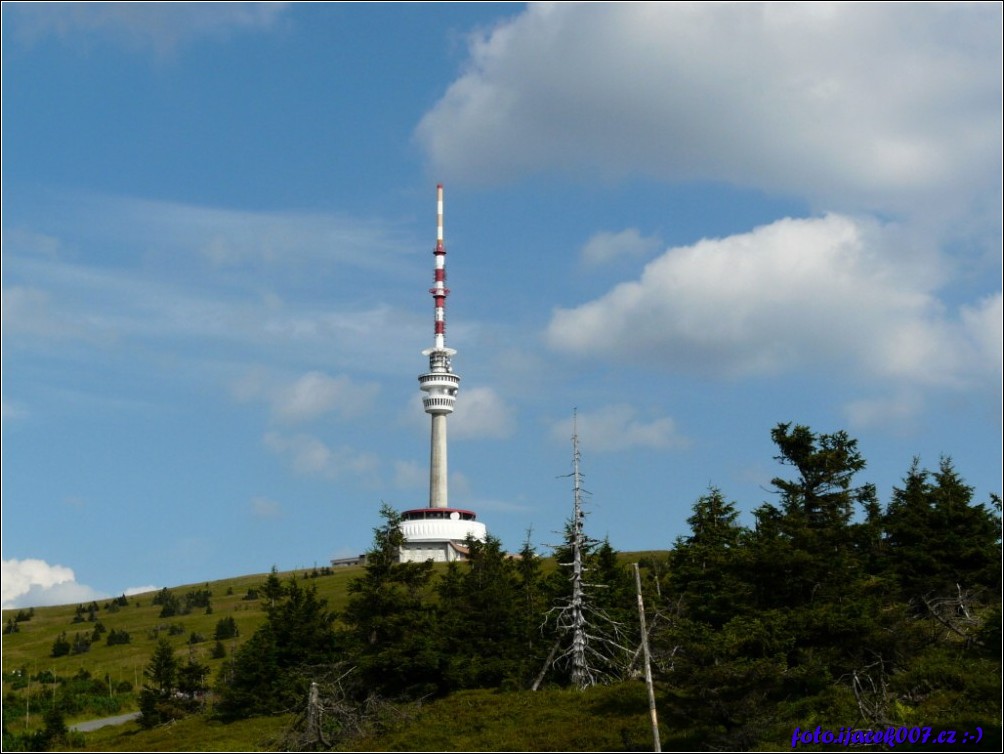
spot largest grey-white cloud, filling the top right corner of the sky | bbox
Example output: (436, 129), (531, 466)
(417, 3), (1001, 219)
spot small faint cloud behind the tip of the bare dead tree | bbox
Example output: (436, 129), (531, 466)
(551, 404), (689, 453)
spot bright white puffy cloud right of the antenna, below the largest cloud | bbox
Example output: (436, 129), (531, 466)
(546, 215), (1000, 386)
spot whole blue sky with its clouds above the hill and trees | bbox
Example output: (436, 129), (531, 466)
(2, 3), (1002, 606)
